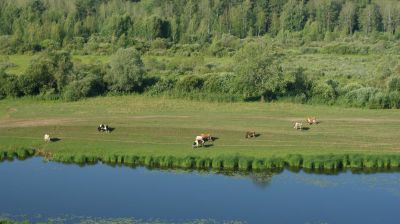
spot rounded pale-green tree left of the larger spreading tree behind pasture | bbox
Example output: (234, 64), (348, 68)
(104, 48), (146, 92)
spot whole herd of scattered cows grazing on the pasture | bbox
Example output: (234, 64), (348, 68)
(44, 117), (319, 148)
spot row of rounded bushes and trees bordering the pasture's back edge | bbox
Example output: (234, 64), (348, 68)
(0, 42), (400, 109)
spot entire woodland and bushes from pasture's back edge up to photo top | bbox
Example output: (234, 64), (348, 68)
(0, 0), (400, 108)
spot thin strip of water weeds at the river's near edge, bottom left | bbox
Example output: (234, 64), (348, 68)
(0, 214), (245, 224)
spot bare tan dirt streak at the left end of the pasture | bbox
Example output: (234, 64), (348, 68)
(0, 118), (82, 127)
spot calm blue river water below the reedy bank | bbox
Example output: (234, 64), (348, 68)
(0, 158), (400, 223)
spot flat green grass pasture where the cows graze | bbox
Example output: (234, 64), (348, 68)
(0, 96), (400, 171)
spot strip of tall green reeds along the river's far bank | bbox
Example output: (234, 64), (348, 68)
(0, 149), (400, 171)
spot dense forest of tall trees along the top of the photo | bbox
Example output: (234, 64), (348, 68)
(0, 0), (400, 53)
